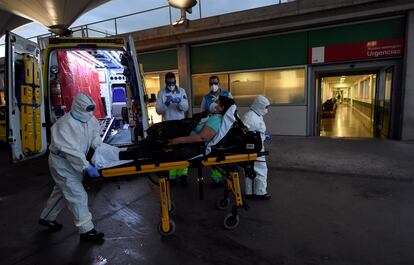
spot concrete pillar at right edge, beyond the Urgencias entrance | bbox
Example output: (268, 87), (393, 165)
(401, 10), (414, 140)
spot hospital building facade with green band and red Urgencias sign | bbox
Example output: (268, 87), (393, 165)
(127, 0), (414, 140)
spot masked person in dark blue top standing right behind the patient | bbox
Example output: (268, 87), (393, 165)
(200, 75), (233, 188)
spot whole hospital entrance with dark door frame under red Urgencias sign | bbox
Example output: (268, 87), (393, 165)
(311, 60), (401, 139)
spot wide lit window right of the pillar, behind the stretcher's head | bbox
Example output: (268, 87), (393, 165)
(193, 68), (305, 106)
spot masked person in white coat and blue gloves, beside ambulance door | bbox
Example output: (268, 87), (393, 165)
(156, 72), (188, 186)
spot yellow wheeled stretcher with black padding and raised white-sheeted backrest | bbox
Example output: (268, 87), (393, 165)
(97, 106), (267, 236)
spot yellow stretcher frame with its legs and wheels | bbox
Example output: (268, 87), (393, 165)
(101, 153), (258, 236)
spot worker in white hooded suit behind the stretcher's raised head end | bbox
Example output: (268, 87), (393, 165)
(242, 95), (271, 200)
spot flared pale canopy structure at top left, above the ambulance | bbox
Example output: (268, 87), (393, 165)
(0, 0), (109, 35)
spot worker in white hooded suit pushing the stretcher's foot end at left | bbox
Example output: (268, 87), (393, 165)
(39, 93), (104, 241)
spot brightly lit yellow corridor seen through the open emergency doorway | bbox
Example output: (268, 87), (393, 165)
(320, 73), (377, 138)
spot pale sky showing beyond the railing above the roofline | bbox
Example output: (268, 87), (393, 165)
(0, 0), (296, 47)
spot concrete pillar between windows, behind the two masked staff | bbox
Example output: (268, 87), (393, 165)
(177, 44), (193, 117)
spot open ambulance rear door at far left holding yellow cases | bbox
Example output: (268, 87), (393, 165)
(5, 32), (47, 162)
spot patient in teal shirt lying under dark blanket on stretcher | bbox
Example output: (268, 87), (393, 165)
(94, 96), (262, 168)
